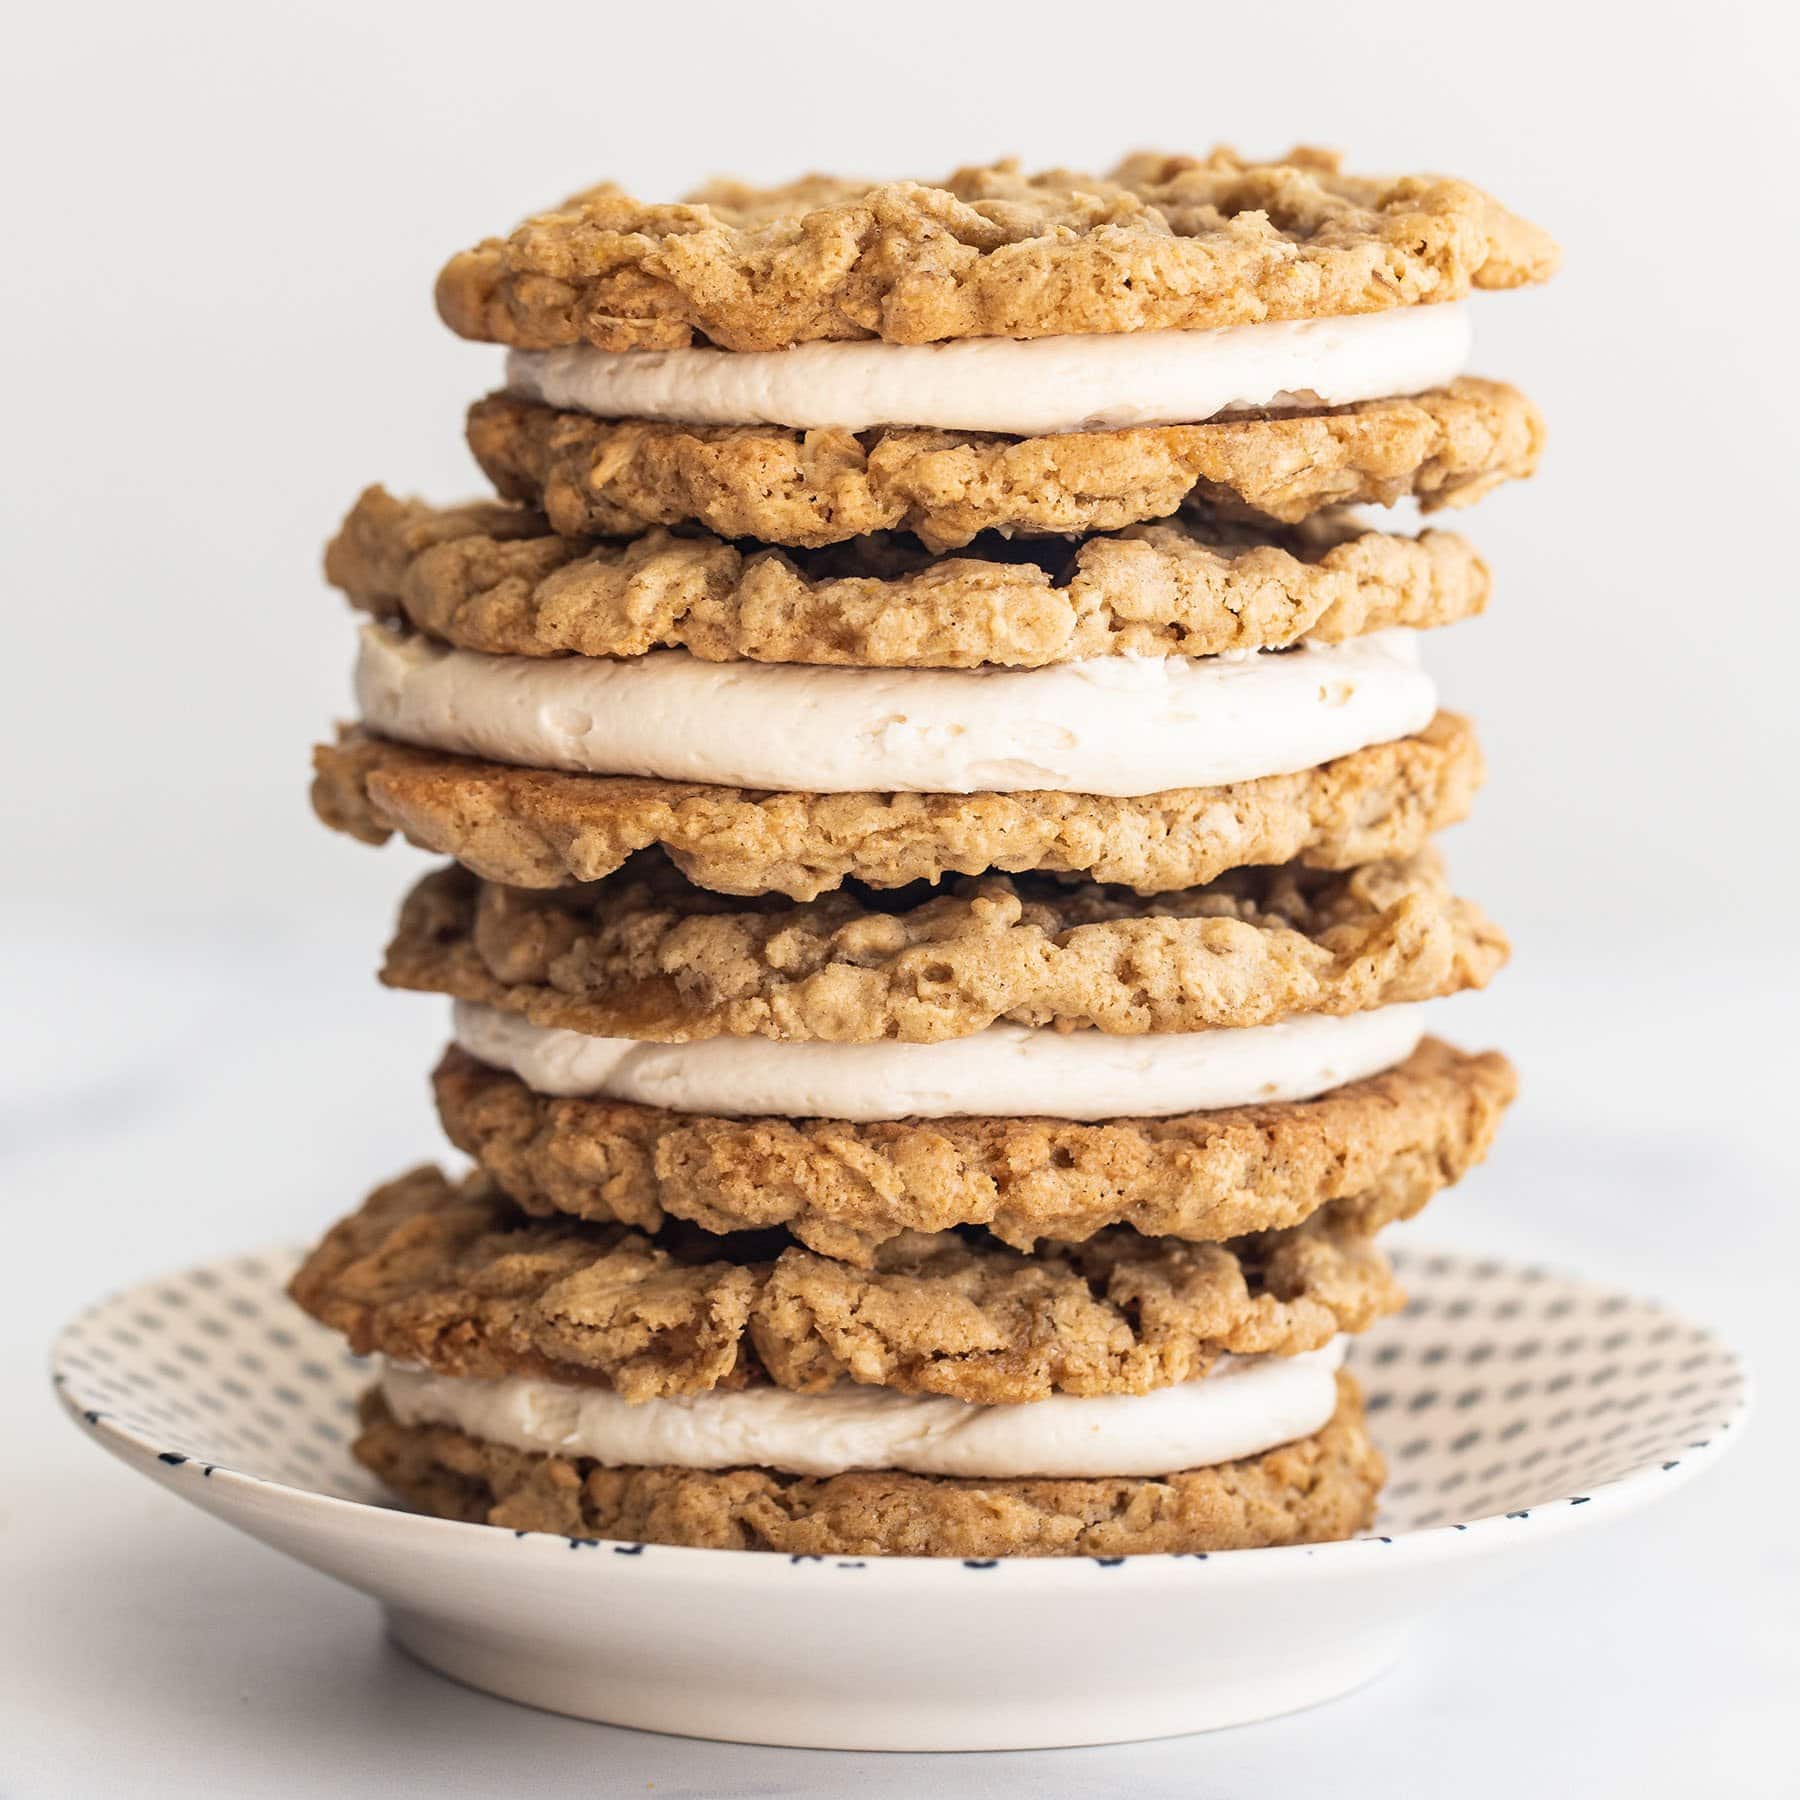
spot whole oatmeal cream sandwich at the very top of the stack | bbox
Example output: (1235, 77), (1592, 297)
(439, 151), (1555, 551)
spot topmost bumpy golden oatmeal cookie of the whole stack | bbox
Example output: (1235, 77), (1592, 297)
(437, 148), (1557, 351)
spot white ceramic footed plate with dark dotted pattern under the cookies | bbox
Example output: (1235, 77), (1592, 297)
(52, 1253), (1746, 1750)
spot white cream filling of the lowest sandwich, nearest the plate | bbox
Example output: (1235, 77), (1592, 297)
(382, 1337), (1345, 1480)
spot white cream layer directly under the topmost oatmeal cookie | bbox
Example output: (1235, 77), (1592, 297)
(506, 306), (1471, 437)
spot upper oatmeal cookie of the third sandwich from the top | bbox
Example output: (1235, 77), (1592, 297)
(382, 848), (1507, 1044)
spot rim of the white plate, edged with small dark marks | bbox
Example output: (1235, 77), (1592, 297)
(49, 1240), (1755, 1586)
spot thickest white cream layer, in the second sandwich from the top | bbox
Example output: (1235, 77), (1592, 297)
(356, 625), (1436, 796)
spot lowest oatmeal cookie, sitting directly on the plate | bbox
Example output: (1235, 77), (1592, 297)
(355, 1373), (1384, 1557)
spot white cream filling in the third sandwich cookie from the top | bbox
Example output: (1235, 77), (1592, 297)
(455, 1001), (1426, 1121)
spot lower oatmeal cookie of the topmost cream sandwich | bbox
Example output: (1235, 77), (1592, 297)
(468, 376), (1544, 551)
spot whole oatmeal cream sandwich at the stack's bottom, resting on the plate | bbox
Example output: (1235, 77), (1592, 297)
(293, 1170), (1400, 1555)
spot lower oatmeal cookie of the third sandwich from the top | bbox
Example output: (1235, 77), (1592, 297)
(432, 1039), (1516, 1267)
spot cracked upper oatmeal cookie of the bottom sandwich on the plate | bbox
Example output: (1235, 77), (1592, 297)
(290, 1168), (1404, 1404)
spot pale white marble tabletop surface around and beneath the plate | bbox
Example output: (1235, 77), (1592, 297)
(0, 907), (1800, 1800)
